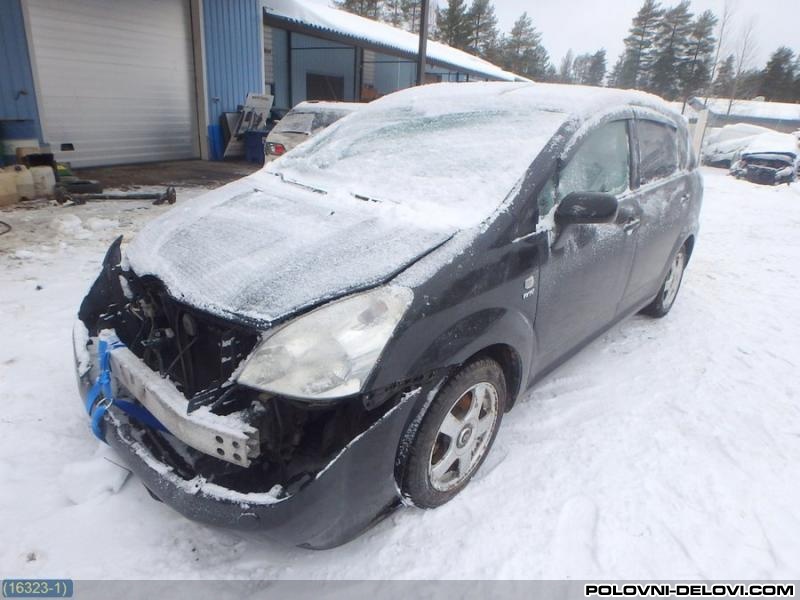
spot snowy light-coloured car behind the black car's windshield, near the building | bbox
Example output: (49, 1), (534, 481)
(264, 100), (365, 161)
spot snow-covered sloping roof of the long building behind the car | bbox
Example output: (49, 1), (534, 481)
(264, 0), (524, 81)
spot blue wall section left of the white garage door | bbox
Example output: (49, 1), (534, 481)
(0, 0), (40, 161)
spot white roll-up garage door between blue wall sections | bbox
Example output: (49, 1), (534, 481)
(25, 0), (199, 167)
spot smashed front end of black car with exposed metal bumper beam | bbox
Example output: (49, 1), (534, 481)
(74, 238), (430, 548)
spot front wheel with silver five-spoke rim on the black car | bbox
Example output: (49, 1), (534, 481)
(402, 358), (507, 508)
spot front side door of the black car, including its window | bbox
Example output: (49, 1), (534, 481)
(534, 119), (639, 371)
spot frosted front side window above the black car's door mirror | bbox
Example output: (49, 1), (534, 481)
(538, 121), (630, 216)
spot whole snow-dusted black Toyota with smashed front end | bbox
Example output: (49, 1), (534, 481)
(74, 83), (702, 548)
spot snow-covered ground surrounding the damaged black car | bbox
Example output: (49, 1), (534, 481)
(0, 169), (800, 579)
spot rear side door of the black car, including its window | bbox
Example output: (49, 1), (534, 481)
(623, 114), (691, 308)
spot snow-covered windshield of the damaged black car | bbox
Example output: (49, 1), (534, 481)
(267, 101), (566, 226)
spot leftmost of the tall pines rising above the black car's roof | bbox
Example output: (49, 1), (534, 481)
(615, 0), (664, 88)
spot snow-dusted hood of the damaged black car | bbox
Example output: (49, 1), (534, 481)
(126, 171), (455, 328)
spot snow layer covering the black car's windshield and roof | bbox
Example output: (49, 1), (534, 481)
(266, 82), (681, 229)
